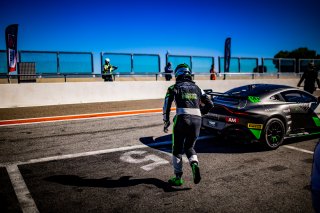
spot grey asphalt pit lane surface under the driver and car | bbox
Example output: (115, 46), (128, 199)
(0, 100), (318, 212)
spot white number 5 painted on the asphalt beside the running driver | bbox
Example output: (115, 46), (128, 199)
(120, 150), (169, 171)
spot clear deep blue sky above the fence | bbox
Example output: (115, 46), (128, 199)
(0, 0), (320, 58)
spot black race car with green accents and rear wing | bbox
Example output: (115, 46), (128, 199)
(202, 84), (320, 149)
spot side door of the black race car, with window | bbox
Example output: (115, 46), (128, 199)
(281, 90), (317, 133)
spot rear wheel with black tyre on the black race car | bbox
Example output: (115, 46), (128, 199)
(262, 118), (285, 149)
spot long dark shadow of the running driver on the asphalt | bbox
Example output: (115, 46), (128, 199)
(44, 175), (191, 192)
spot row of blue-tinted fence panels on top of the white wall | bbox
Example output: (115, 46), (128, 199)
(0, 50), (320, 82)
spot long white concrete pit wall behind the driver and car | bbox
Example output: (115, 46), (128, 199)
(0, 78), (318, 111)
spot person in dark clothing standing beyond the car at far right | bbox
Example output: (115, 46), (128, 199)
(297, 62), (320, 94)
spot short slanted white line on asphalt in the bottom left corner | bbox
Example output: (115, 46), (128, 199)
(6, 165), (39, 213)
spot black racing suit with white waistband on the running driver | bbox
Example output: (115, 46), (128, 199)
(163, 76), (213, 177)
